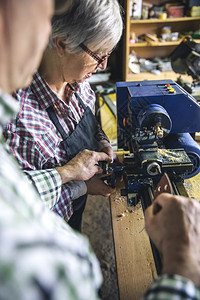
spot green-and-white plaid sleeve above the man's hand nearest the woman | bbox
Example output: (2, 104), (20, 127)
(24, 169), (62, 208)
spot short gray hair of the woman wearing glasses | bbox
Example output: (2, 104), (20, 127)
(49, 0), (123, 53)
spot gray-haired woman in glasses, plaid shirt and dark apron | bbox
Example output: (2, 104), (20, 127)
(5, 0), (122, 230)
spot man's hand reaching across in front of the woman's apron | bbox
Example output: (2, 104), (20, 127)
(56, 150), (111, 183)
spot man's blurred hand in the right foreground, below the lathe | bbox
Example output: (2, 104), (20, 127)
(145, 193), (200, 286)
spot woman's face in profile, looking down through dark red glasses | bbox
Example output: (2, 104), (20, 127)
(60, 51), (107, 83)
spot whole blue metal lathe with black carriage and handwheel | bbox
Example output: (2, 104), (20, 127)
(106, 80), (200, 274)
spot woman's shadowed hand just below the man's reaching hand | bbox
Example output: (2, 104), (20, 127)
(86, 175), (115, 197)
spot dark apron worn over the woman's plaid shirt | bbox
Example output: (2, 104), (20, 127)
(47, 93), (98, 231)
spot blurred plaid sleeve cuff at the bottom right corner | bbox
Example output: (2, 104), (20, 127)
(142, 275), (200, 300)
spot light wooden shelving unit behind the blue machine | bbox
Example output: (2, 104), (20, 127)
(123, 0), (200, 81)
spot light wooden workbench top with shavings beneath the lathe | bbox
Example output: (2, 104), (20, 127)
(110, 175), (200, 300)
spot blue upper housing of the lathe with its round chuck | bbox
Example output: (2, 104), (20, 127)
(116, 80), (200, 178)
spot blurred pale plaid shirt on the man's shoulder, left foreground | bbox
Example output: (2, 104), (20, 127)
(0, 91), (102, 300)
